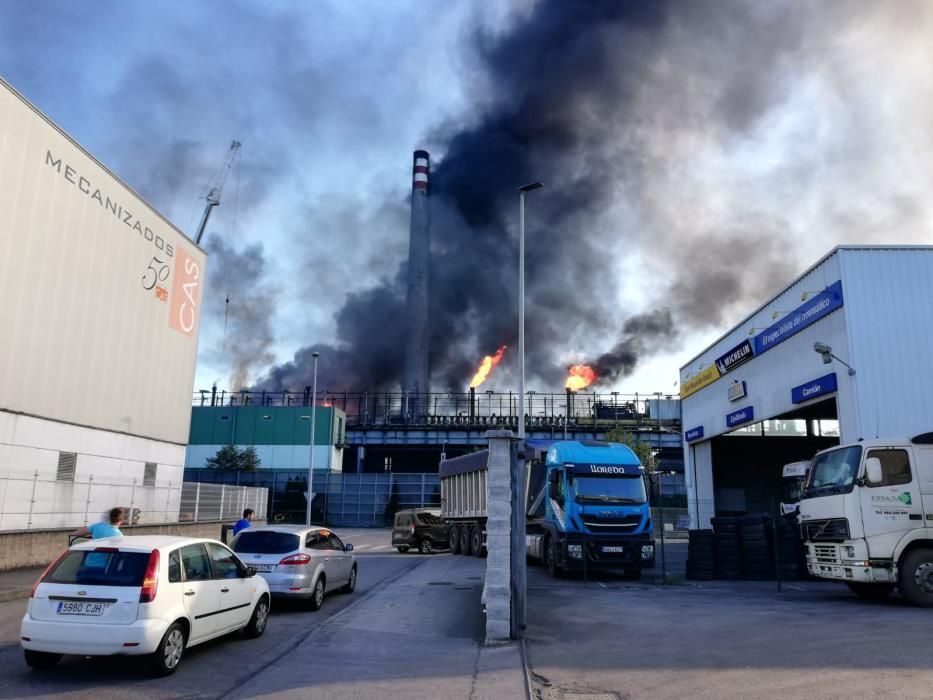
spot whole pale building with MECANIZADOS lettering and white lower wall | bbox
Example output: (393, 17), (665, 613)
(0, 80), (205, 530)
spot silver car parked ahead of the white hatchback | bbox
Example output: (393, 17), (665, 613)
(232, 525), (357, 610)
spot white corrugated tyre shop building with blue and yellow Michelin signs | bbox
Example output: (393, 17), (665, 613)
(680, 246), (933, 527)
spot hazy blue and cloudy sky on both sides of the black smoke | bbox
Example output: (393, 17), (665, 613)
(0, 0), (933, 392)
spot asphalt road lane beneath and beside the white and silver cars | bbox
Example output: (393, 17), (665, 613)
(0, 530), (425, 700)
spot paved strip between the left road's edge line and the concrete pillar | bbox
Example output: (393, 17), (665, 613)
(233, 556), (527, 700)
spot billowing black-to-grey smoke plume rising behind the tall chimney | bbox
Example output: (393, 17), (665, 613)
(256, 0), (932, 390)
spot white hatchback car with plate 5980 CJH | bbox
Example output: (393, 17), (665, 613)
(20, 536), (270, 675)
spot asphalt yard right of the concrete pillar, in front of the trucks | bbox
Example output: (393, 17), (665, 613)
(526, 567), (933, 699)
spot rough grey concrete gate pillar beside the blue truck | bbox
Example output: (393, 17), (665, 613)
(483, 430), (515, 644)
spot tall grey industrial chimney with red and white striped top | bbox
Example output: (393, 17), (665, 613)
(402, 151), (431, 416)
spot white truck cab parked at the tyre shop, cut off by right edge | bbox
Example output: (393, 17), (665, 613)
(800, 433), (933, 607)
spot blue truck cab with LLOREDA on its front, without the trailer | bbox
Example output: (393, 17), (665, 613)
(527, 440), (654, 579)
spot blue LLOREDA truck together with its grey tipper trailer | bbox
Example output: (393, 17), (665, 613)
(440, 440), (655, 579)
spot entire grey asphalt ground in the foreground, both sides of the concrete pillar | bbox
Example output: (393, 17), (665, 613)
(0, 530), (933, 700)
